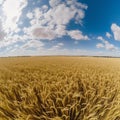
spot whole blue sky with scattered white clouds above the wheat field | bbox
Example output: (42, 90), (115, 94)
(0, 0), (120, 56)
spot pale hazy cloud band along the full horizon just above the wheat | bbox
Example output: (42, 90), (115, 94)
(3, 48), (120, 56)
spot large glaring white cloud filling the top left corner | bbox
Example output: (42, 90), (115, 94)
(0, 0), (27, 46)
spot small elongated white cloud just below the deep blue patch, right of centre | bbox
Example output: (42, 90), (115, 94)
(68, 30), (89, 40)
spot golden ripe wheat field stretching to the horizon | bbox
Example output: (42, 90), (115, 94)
(0, 56), (120, 120)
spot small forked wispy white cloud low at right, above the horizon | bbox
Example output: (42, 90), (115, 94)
(96, 36), (118, 51)
